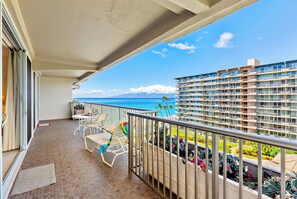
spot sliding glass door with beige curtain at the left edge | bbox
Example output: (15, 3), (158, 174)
(0, 5), (32, 198)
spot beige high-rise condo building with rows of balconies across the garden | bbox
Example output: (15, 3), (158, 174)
(176, 59), (297, 139)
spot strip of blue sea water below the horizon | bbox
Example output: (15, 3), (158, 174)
(74, 98), (175, 116)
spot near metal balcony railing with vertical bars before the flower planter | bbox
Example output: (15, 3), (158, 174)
(128, 113), (297, 199)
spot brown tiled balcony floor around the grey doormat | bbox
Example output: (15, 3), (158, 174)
(10, 120), (158, 199)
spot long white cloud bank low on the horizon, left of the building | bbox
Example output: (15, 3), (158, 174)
(129, 84), (176, 94)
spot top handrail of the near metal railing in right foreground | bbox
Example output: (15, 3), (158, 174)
(127, 112), (297, 150)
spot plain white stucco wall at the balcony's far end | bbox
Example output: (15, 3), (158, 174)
(40, 77), (75, 120)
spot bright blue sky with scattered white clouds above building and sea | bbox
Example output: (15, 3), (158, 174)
(74, 0), (297, 97)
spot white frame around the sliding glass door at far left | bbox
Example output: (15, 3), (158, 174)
(0, 3), (31, 198)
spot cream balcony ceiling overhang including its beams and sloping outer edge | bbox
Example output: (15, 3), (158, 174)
(4, 0), (256, 84)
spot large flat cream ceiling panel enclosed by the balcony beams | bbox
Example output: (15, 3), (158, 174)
(19, 0), (167, 65)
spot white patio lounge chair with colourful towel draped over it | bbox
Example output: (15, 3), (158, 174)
(84, 122), (128, 167)
